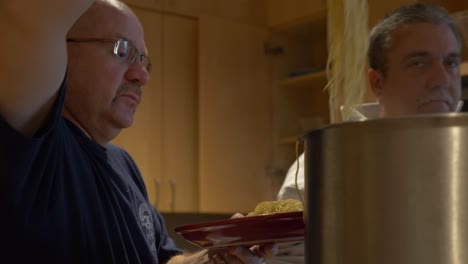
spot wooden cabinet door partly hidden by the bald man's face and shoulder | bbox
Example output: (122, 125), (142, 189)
(113, 8), (163, 205)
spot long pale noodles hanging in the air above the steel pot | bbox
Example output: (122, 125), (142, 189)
(325, 0), (369, 123)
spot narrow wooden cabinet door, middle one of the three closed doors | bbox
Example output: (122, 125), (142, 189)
(160, 15), (198, 212)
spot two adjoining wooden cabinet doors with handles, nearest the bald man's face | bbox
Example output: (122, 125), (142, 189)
(113, 6), (198, 212)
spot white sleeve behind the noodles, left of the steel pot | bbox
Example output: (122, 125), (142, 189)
(277, 153), (304, 200)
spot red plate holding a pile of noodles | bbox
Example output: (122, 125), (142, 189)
(175, 212), (304, 248)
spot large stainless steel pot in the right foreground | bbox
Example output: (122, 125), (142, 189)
(303, 114), (468, 264)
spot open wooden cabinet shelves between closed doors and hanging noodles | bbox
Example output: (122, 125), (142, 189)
(268, 0), (329, 173)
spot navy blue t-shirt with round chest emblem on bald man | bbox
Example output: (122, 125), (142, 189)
(0, 80), (181, 264)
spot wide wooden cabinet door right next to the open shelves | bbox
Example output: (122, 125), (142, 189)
(199, 17), (274, 213)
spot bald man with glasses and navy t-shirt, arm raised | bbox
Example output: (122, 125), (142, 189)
(0, 0), (276, 264)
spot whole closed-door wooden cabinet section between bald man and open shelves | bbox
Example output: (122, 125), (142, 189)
(114, 0), (276, 213)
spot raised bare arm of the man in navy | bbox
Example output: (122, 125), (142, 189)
(0, 0), (93, 135)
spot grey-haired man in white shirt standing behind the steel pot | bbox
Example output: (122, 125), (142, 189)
(267, 3), (463, 264)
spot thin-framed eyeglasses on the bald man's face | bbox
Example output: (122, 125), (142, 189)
(67, 38), (152, 72)
